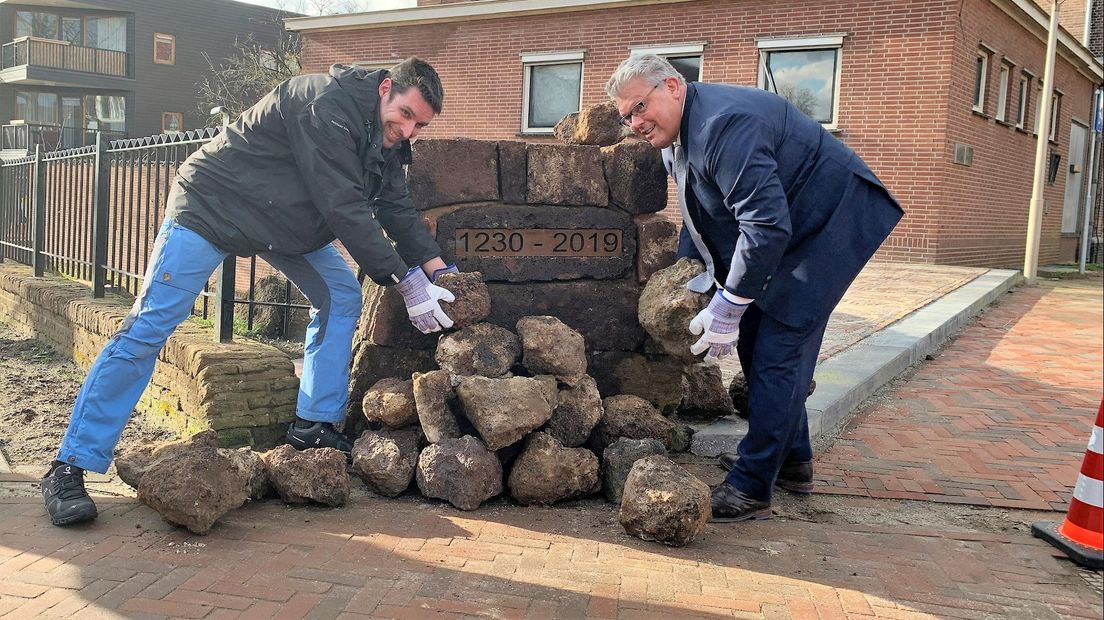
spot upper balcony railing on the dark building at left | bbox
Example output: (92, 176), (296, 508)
(0, 36), (129, 77)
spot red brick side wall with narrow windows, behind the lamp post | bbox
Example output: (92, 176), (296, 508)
(935, 0), (1092, 267)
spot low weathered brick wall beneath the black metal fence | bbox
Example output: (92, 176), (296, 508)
(0, 263), (299, 449)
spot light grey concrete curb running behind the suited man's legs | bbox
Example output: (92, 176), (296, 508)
(690, 269), (1023, 457)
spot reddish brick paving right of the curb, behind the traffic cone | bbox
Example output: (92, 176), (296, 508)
(816, 274), (1104, 512)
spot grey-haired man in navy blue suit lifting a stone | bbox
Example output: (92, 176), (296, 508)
(606, 54), (903, 522)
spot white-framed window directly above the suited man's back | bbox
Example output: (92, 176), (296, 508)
(758, 34), (843, 128)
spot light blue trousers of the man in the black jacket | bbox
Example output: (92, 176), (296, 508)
(57, 218), (361, 472)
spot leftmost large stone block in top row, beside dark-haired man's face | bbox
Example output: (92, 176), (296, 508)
(406, 138), (499, 210)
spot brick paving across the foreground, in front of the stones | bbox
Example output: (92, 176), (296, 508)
(0, 487), (1101, 619)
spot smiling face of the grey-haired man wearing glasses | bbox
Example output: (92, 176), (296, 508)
(614, 77), (687, 149)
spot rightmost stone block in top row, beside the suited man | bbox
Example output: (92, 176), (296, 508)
(602, 140), (667, 213)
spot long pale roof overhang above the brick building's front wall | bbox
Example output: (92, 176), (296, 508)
(284, 0), (691, 32)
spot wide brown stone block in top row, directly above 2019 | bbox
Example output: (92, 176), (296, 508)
(526, 145), (609, 206)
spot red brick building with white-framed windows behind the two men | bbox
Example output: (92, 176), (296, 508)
(287, 0), (1104, 267)
